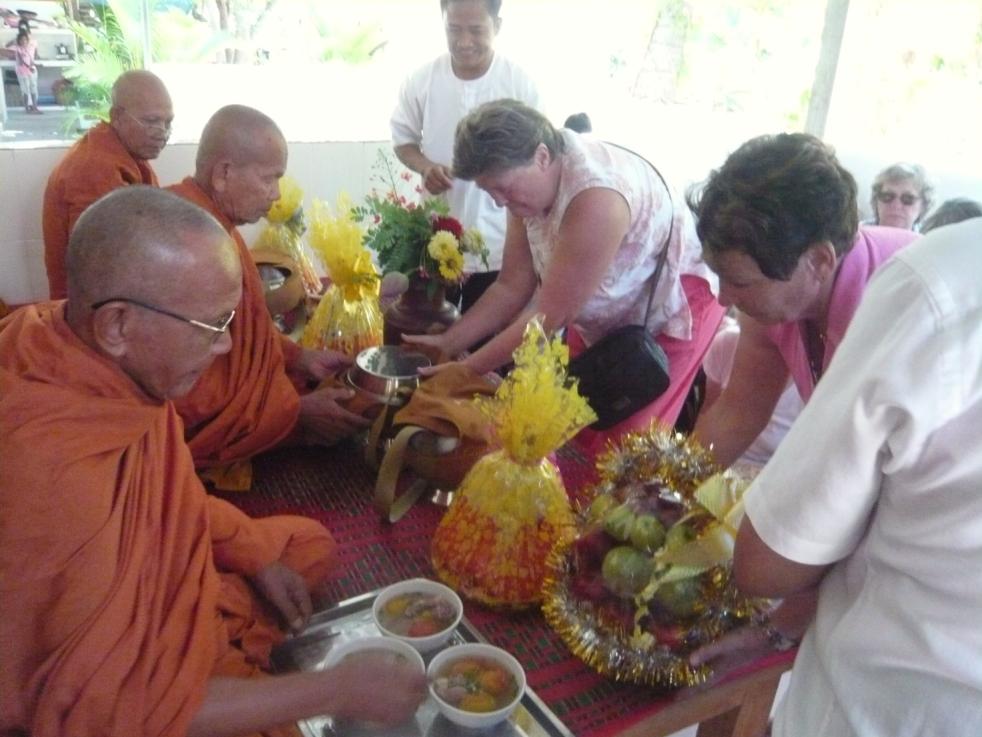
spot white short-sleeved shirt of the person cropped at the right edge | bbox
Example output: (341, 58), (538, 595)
(746, 220), (982, 737)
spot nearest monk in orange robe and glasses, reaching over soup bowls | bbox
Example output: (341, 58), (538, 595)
(0, 187), (426, 737)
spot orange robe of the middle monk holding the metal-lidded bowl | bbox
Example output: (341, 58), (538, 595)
(168, 177), (301, 468)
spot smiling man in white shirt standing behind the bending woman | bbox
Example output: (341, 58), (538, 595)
(391, 0), (539, 310)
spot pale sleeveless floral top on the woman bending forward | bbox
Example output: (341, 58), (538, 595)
(524, 130), (719, 345)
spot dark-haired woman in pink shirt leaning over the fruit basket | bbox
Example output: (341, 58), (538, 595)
(690, 133), (917, 466)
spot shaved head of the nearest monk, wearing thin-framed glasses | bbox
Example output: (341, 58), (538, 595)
(66, 186), (242, 400)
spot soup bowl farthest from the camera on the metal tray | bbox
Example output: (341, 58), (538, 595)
(372, 578), (464, 653)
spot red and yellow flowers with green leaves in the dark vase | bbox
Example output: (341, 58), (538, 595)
(352, 151), (488, 286)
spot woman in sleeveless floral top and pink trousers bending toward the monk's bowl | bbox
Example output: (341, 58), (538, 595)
(406, 100), (723, 447)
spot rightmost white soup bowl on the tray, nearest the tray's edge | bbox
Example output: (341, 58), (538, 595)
(426, 642), (525, 729)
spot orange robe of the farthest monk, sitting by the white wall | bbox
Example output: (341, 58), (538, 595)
(41, 123), (159, 299)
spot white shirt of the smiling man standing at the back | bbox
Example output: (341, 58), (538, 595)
(391, 53), (539, 272)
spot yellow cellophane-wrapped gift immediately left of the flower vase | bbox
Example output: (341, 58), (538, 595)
(300, 195), (382, 357)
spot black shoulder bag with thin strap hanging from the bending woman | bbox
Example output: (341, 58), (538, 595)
(568, 144), (675, 430)
